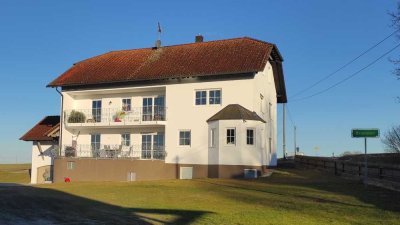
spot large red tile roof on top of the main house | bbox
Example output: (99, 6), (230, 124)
(48, 37), (282, 87)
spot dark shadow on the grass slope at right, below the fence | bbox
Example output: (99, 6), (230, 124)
(199, 169), (400, 212)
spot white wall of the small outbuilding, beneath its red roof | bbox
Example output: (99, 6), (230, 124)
(31, 141), (57, 184)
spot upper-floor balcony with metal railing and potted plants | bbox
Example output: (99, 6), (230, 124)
(64, 106), (167, 127)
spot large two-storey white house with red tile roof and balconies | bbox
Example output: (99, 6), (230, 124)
(48, 37), (287, 182)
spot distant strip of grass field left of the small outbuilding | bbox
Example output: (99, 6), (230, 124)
(0, 164), (31, 184)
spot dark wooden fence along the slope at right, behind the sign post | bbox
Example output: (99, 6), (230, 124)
(295, 156), (400, 183)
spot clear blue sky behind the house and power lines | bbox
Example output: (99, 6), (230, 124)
(0, 0), (400, 163)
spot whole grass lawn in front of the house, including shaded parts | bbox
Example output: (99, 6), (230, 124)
(0, 164), (400, 224)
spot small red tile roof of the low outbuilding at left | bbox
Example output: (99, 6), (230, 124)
(20, 116), (60, 141)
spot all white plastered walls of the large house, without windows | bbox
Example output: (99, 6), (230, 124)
(60, 63), (277, 166)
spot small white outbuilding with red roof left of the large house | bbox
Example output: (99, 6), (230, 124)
(20, 116), (60, 184)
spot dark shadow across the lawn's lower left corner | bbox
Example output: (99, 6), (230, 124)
(0, 184), (210, 224)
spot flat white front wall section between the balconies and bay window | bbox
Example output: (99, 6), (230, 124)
(165, 79), (254, 164)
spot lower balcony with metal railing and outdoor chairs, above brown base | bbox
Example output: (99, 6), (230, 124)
(58, 145), (166, 160)
